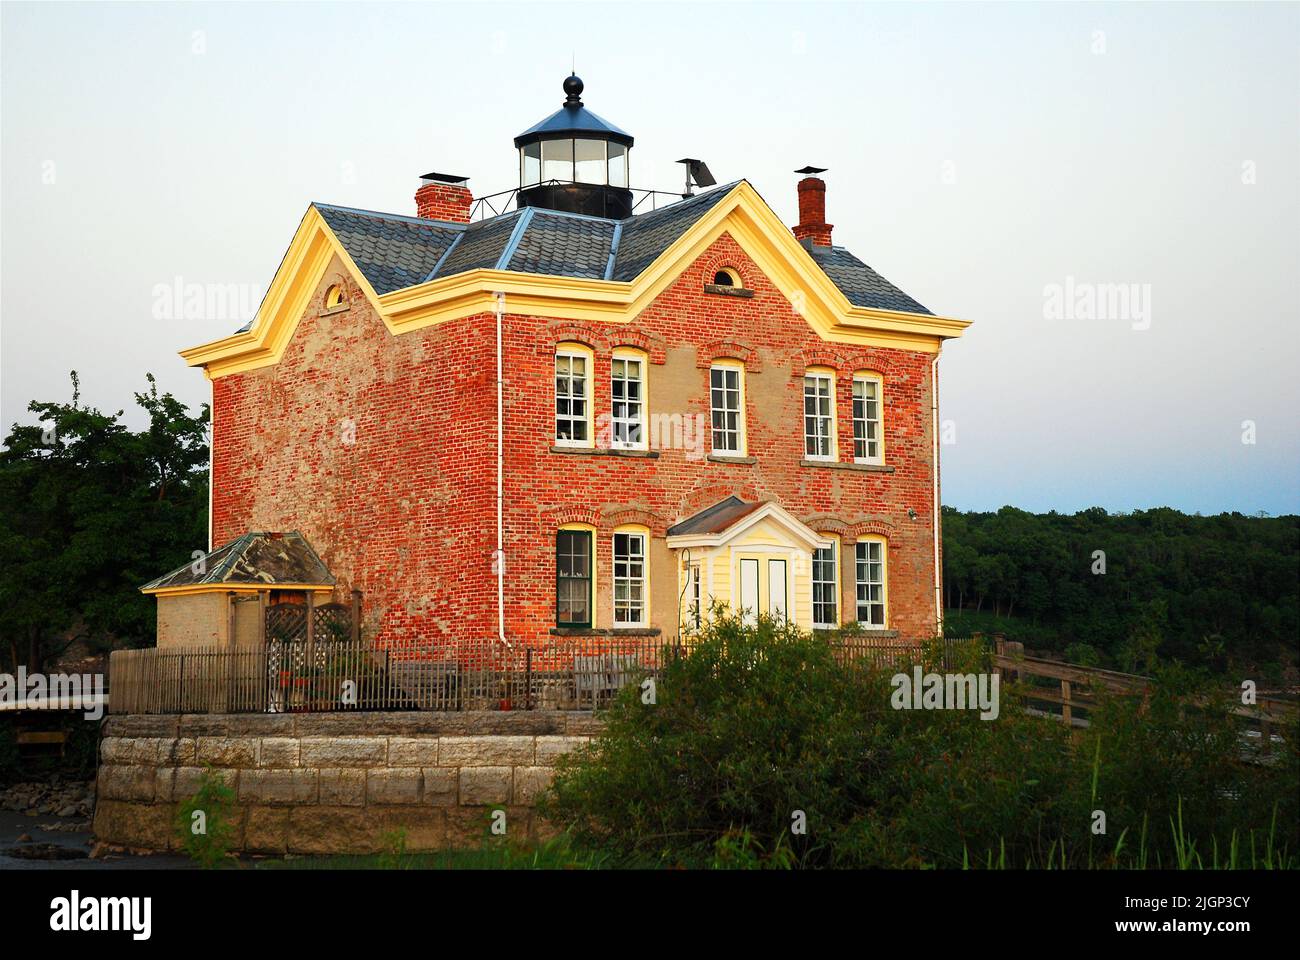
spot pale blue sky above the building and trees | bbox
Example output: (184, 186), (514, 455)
(0, 3), (1300, 513)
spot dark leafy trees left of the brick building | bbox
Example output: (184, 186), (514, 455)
(0, 371), (209, 671)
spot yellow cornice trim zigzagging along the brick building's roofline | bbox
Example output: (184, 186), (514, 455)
(188, 181), (970, 377)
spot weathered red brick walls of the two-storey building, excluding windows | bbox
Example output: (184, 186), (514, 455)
(213, 228), (936, 643)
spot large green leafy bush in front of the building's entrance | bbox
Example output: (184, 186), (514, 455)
(542, 615), (1300, 868)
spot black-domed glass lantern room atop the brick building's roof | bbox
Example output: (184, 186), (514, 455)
(515, 74), (632, 220)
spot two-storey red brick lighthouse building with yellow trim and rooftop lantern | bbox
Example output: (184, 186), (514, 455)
(183, 77), (967, 643)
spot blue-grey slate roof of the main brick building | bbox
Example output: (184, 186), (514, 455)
(301, 183), (930, 321)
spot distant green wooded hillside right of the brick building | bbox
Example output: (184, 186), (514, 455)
(943, 506), (1300, 676)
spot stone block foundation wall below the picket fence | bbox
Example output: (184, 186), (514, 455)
(95, 712), (601, 853)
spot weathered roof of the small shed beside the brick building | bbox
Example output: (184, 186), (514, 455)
(140, 529), (334, 593)
